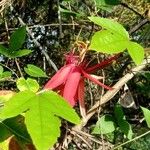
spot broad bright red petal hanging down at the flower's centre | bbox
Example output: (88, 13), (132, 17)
(63, 67), (81, 106)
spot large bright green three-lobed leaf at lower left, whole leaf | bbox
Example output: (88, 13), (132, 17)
(0, 91), (80, 150)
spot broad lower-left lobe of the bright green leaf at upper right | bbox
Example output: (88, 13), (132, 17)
(89, 30), (129, 54)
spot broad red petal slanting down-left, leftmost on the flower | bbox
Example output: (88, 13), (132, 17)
(44, 64), (74, 89)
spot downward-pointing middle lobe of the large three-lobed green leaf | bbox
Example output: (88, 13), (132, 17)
(25, 105), (61, 150)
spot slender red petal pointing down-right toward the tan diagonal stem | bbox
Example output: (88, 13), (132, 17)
(82, 70), (113, 90)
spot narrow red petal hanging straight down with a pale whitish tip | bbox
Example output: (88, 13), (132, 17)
(78, 79), (86, 118)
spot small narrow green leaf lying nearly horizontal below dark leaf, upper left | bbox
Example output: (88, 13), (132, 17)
(9, 49), (32, 58)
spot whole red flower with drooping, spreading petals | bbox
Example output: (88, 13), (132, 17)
(44, 53), (116, 106)
